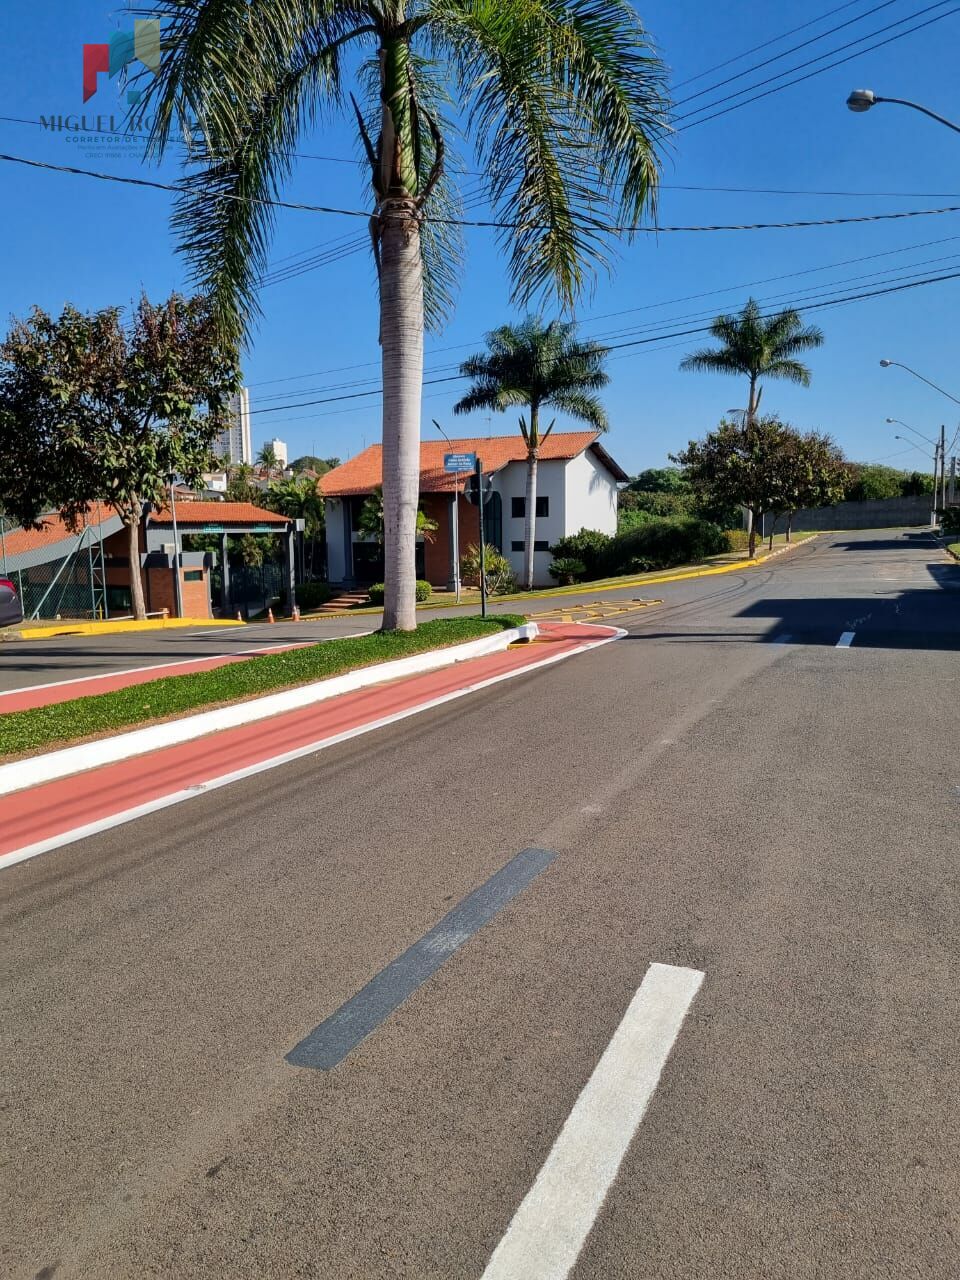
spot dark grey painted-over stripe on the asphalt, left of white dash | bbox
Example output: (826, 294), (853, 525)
(285, 849), (557, 1071)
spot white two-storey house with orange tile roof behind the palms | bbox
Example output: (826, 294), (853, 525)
(319, 431), (628, 586)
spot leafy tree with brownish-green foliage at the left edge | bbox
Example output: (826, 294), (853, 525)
(0, 294), (239, 618)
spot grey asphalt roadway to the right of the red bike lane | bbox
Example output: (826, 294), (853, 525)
(0, 524), (960, 1280)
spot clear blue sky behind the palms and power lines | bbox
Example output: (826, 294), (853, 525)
(0, 0), (960, 471)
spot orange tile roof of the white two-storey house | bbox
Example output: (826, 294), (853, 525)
(320, 431), (628, 498)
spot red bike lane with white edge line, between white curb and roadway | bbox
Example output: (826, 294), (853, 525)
(0, 623), (621, 867)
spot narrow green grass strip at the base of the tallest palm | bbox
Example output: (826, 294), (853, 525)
(0, 613), (525, 756)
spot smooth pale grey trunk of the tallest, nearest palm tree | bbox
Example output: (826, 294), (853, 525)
(380, 198), (424, 631)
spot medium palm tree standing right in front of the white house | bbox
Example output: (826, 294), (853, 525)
(453, 316), (609, 590)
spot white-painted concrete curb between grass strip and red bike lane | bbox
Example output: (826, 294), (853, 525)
(0, 622), (539, 796)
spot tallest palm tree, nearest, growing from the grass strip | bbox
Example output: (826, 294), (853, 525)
(140, 0), (668, 630)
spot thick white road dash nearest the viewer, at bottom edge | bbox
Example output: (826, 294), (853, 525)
(483, 964), (704, 1280)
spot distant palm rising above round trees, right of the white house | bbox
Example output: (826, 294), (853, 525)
(680, 298), (823, 422)
